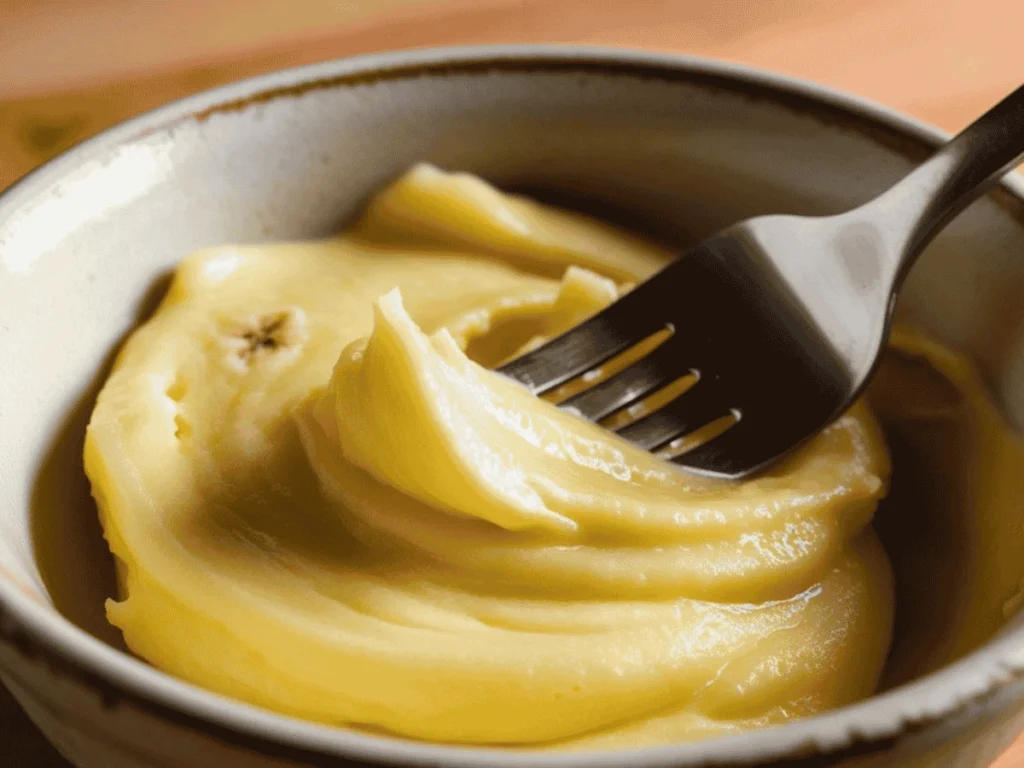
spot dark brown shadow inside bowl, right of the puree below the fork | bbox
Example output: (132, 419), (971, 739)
(868, 342), (1024, 690)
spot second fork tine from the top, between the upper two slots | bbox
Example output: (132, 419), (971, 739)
(559, 334), (692, 421)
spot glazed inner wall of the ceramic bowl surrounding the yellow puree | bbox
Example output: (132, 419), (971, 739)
(0, 49), (1024, 741)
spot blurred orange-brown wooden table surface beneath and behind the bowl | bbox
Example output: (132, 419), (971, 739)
(0, 0), (1024, 768)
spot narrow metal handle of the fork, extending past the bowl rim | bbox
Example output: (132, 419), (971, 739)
(865, 85), (1024, 284)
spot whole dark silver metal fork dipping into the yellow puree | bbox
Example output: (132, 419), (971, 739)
(499, 86), (1024, 477)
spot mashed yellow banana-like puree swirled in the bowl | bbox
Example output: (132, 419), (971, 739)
(85, 166), (893, 748)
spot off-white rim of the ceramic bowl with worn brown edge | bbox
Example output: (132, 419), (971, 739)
(0, 44), (1024, 768)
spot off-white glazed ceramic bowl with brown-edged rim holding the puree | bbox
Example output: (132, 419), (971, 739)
(0, 46), (1024, 768)
